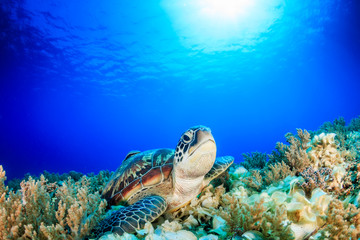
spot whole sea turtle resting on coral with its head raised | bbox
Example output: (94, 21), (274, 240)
(92, 126), (234, 238)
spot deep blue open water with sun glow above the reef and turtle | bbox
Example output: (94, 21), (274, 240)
(0, 0), (360, 178)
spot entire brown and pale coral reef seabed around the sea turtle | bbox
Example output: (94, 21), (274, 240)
(0, 117), (360, 240)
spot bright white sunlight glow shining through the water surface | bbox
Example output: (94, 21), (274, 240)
(162, 0), (285, 53)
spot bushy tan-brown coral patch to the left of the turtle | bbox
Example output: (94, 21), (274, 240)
(0, 165), (106, 240)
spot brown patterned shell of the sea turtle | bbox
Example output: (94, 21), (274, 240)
(102, 149), (174, 205)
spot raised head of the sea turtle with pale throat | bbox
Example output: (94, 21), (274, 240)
(174, 126), (216, 178)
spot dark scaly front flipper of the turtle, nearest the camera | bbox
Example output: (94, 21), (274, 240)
(90, 196), (167, 239)
